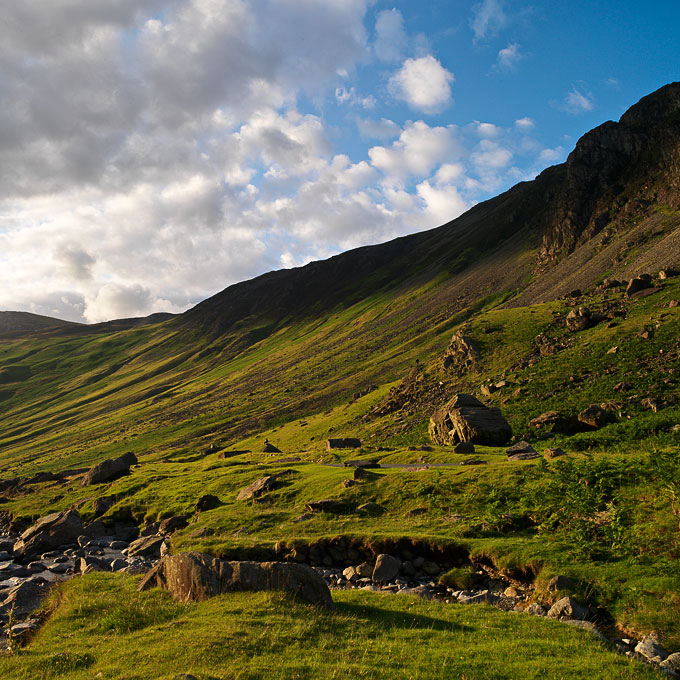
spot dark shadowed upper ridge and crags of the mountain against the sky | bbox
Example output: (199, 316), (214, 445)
(177, 82), (680, 335)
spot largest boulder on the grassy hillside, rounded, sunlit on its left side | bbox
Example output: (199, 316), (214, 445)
(428, 394), (512, 446)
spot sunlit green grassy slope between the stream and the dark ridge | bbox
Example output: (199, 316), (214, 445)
(0, 210), (680, 677)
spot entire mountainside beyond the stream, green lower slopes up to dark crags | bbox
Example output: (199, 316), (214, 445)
(0, 83), (680, 664)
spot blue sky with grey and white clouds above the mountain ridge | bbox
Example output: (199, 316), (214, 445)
(0, 0), (680, 323)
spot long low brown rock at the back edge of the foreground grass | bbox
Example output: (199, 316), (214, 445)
(139, 552), (333, 609)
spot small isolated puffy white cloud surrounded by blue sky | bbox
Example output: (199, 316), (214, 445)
(388, 55), (454, 113)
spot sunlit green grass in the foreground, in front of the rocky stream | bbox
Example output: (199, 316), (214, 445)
(0, 574), (657, 680)
